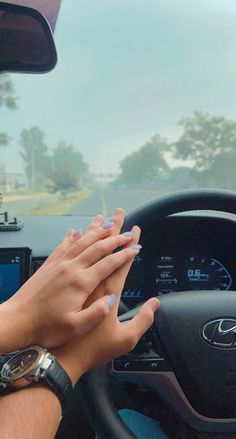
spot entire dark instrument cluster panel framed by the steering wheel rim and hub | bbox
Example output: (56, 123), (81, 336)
(122, 217), (236, 308)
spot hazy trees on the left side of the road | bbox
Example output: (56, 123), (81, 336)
(0, 74), (91, 192)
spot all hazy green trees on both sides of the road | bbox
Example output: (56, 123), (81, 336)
(0, 74), (236, 192)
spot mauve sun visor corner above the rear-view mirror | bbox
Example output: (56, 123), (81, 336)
(3, 0), (61, 32)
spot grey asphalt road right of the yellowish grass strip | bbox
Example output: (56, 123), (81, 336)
(68, 189), (160, 216)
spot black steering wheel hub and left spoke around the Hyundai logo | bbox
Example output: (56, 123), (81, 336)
(110, 291), (236, 432)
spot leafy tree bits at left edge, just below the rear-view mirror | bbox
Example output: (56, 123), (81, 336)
(0, 73), (16, 147)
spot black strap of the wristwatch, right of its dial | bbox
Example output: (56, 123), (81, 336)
(44, 357), (73, 411)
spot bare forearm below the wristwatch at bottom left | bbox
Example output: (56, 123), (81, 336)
(0, 384), (61, 439)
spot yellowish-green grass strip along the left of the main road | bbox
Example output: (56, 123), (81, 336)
(21, 189), (93, 216)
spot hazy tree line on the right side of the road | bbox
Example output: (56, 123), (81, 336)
(113, 111), (236, 190)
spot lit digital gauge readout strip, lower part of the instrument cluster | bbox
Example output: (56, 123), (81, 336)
(122, 255), (233, 305)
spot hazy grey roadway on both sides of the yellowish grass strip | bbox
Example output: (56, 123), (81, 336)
(2, 189), (164, 216)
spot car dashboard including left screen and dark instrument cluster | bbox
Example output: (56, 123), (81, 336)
(0, 214), (236, 308)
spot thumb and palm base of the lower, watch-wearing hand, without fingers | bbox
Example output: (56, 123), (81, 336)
(53, 298), (159, 383)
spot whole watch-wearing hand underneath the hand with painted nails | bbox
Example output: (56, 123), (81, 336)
(54, 214), (159, 382)
